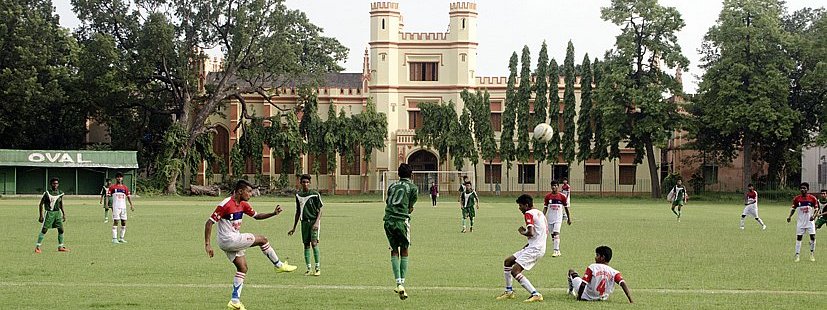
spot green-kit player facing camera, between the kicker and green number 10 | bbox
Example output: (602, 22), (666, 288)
(287, 174), (324, 276)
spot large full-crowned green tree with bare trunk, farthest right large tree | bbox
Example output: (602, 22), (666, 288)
(698, 0), (800, 188)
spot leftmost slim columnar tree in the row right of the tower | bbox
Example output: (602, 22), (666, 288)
(500, 52), (517, 191)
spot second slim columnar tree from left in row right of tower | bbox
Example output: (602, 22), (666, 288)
(516, 46), (533, 190)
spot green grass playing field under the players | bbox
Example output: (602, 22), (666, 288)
(0, 196), (827, 309)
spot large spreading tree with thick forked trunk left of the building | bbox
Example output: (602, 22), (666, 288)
(72, 0), (347, 192)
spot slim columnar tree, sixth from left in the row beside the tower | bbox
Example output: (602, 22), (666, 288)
(577, 53), (594, 162)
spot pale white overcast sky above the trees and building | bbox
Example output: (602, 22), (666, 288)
(54, 0), (825, 93)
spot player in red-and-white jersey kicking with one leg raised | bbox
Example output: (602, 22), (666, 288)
(204, 180), (296, 310)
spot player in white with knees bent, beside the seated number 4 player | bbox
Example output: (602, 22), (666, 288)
(497, 194), (548, 302)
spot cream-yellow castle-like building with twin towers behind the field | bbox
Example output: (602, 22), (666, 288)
(199, 2), (651, 193)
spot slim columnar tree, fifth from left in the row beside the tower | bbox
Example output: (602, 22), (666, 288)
(561, 41), (577, 170)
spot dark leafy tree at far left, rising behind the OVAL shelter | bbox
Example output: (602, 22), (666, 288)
(0, 0), (91, 149)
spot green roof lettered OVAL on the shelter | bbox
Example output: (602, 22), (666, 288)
(0, 149), (138, 169)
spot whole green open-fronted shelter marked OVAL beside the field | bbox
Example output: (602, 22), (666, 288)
(0, 149), (138, 195)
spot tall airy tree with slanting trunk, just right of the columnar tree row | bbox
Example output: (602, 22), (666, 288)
(596, 0), (689, 197)
